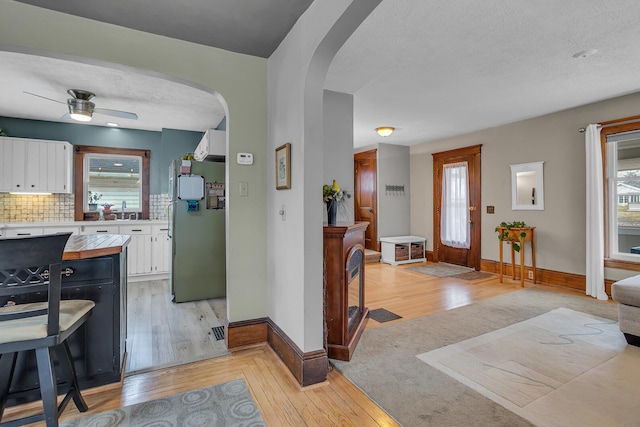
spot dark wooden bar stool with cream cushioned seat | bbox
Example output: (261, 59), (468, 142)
(0, 233), (95, 427)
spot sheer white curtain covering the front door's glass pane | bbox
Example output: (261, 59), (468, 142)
(440, 162), (471, 249)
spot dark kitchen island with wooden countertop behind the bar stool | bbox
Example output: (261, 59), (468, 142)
(0, 234), (131, 406)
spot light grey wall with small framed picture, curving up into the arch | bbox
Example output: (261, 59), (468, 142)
(267, 0), (380, 352)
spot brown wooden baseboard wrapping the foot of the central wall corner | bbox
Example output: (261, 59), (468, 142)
(224, 317), (329, 387)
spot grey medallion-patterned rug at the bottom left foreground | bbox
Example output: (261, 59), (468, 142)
(60, 379), (266, 427)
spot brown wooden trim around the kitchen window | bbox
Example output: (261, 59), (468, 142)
(73, 145), (151, 221)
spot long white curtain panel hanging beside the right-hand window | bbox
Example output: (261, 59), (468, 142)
(585, 125), (609, 300)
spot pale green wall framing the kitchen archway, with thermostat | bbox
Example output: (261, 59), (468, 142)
(0, 0), (273, 322)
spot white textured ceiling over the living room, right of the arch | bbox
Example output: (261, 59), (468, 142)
(326, 0), (640, 146)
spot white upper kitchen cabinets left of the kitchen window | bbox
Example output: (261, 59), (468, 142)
(0, 137), (73, 194)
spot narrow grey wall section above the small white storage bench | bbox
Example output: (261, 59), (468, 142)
(378, 144), (411, 238)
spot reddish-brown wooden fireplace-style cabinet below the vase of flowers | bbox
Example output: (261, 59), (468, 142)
(324, 222), (369, 360)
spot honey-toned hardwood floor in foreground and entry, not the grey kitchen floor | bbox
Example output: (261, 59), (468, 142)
(3, 264), (583, 426)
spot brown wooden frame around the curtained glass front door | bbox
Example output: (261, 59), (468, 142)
(432, 144), (482, 270)
